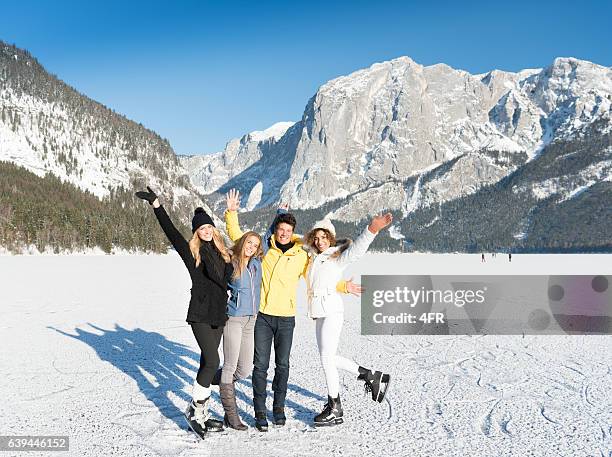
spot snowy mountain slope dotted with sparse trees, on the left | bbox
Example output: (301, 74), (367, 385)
(0, 42), (213, 224)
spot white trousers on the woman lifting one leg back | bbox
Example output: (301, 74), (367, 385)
(315, 313), (359, 398)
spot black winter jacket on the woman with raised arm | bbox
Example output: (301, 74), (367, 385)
(154, 206), (233, 326)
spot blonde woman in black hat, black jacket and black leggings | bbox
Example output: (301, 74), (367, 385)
(136, 187), (233, 438)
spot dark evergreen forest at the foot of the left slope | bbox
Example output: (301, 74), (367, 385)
(0, 162), (191, 253)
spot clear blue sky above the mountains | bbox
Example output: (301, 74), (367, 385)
(0, 0), (612, 154)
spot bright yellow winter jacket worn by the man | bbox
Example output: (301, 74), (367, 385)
(225, 211), (347, 317)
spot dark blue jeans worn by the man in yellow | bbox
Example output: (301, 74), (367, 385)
(253, 313), (295, 412)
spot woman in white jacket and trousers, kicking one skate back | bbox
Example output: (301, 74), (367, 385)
(305, 213), (393, 426)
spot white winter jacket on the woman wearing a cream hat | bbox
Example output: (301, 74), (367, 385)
(306, 227), (376, 319)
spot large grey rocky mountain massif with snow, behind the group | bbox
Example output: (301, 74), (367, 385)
(185, 57), (612, 228)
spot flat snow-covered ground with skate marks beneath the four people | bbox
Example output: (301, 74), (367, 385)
(0, 254), (612, 457)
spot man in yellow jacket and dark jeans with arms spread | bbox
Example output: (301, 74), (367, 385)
(225, 189), (348, 432)
